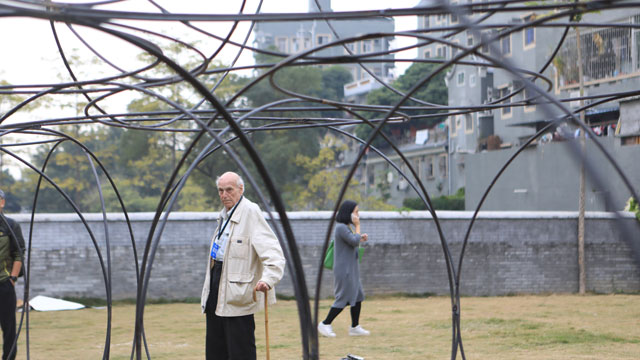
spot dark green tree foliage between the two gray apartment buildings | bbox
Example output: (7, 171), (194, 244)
(356, 63), (448, 147)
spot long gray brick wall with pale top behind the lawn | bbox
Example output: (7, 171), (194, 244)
(10, 212), (640, 299)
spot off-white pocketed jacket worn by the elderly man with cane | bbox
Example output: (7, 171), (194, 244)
(200, 197), (285, 316)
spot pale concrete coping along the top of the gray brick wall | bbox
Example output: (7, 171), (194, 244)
(7, 211), (634, 223)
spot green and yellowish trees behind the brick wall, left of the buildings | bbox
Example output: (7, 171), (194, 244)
(0, 44), (378, 212)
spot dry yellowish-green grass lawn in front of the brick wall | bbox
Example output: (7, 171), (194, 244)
(12, 295), (640, 360)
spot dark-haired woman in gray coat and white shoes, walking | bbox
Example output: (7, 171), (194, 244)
(318, 200), (369, 337)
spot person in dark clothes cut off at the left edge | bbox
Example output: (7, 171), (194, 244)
(0, 190), (24, 360)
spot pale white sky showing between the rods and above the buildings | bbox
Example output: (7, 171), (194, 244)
(0, 0), (420, 177)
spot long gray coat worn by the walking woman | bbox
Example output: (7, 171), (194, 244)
(332, 223), (364, 309)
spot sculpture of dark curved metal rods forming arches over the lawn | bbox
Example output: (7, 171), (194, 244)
(0, 0), (640, 359)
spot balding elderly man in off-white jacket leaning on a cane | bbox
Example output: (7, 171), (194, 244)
(201, 172), (285, 360)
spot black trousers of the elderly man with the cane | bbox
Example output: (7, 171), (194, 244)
(205, 262), (256, 360)
